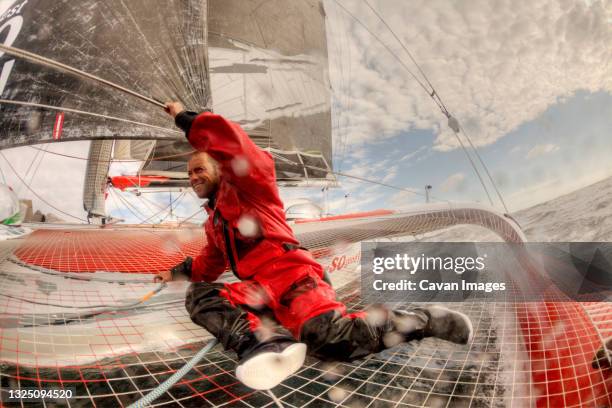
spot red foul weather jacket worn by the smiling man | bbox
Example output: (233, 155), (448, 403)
(176, 112), (323, 308)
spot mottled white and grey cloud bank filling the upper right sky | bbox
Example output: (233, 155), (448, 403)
(325, 0), (612, 151)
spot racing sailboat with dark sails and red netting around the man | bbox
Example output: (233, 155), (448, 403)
(0, 0), (612, 407)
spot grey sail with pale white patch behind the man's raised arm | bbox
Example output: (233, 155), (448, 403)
(136, 0), (336, 186)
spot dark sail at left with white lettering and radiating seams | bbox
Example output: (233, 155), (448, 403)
(0, 0), (211, 148)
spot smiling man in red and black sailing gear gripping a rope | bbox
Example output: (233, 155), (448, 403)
(157, 102), (472, 389)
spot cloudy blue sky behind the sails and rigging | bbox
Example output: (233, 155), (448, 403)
(0, 0), (612, 222)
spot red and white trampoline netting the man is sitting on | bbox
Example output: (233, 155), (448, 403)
(0, 213), (612, 407)
